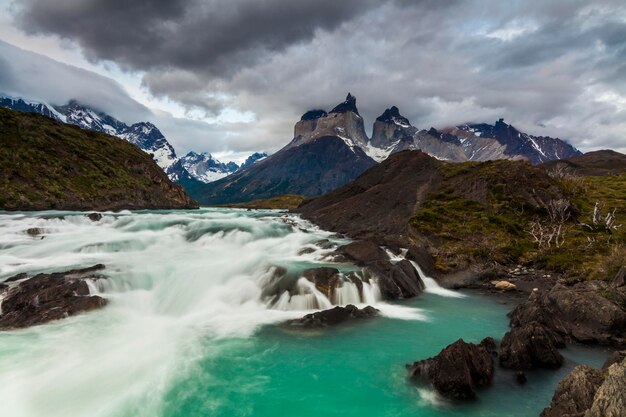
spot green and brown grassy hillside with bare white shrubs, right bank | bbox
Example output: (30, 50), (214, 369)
(409, 161), (626, 279)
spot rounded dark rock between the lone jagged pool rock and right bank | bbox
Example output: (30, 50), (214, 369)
(499, 322), (565, 371)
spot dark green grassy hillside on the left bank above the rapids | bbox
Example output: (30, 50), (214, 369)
(0, 108), (197, 210)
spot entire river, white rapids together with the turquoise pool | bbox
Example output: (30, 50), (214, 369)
(0, 209), (605, 417)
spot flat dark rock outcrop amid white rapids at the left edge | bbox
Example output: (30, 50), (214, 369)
(0, 264), (106, 330)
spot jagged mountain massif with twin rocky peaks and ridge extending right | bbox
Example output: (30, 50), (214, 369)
(190, 93), (581, 205)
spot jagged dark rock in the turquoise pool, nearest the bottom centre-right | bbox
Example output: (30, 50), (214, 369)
(407, 338), (495, 400)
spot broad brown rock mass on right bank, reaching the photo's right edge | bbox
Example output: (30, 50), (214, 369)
(509, 281), (626, 348)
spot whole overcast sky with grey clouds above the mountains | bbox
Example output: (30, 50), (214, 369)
(0, 0), (626, 161)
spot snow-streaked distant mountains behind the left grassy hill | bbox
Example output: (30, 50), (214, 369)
(0, 96), (267, 183)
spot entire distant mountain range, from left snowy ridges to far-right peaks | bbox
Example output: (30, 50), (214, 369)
(0, 93), (581, 205)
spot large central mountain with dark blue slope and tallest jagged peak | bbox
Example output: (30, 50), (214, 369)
(188, 94), (376, 205)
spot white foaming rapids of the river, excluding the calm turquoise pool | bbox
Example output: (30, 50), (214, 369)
(0, 209), (425, 417)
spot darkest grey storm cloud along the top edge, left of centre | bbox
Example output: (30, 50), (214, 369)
(19, 0), (376, 76)
